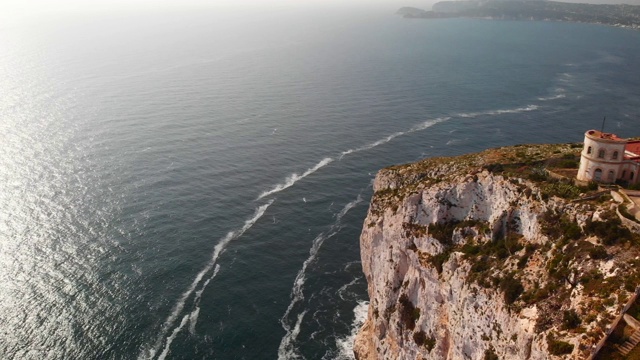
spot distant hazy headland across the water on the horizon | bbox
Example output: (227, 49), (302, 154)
(396, 0), (640, 29)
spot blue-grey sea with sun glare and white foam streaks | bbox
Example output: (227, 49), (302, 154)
(0, 8), (640, 359)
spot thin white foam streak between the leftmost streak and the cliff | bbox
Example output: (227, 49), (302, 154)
(278, 195), (362, 360)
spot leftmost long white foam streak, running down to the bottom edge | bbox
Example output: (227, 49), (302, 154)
(138, 200), (273, 359)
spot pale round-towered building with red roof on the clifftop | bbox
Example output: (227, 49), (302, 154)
(577, 130), (640, 184)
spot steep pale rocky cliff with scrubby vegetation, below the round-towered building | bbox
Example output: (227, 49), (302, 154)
(354, 144), (640, 360)
